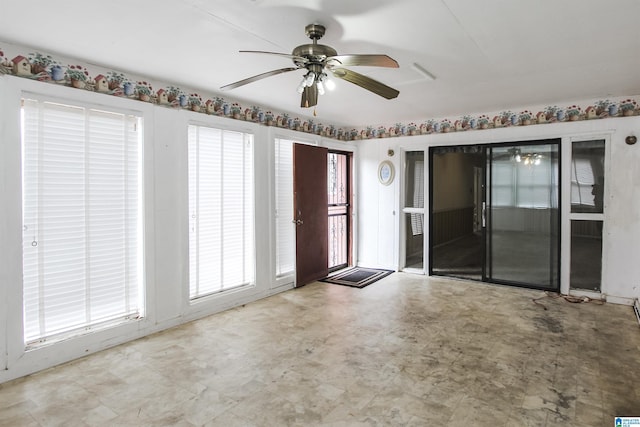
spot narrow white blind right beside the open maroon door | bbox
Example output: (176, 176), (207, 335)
(275, 139), (296, 277)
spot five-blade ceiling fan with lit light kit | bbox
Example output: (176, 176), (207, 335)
(220, 24), (400, 108)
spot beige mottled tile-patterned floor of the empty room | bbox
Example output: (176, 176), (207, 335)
(0, 273), (640, 427)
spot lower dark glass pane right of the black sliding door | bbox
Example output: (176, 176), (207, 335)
(571, 221), (602, 292)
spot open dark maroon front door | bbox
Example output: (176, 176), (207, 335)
(293, 144), (329, 287)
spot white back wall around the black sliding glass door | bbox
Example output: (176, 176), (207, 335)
(358, 116), (640, 303)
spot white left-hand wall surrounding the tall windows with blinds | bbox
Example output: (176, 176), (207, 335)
(0, 76), (354, 383)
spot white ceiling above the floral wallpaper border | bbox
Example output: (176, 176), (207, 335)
(0, 0), (640, 126)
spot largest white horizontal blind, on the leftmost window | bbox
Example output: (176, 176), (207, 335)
(22, 99), (143, 344)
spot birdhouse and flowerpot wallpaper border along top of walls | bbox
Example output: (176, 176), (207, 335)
(0, 47), (640, 141)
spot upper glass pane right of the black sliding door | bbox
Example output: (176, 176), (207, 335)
(571, 140), (604, 213)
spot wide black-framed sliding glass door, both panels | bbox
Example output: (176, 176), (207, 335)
(429, 140), (560, 290)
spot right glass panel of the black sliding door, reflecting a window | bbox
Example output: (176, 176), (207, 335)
(485, 142), (560, 290)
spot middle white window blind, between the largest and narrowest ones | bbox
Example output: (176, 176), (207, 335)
(188, 125), (255, 299)
